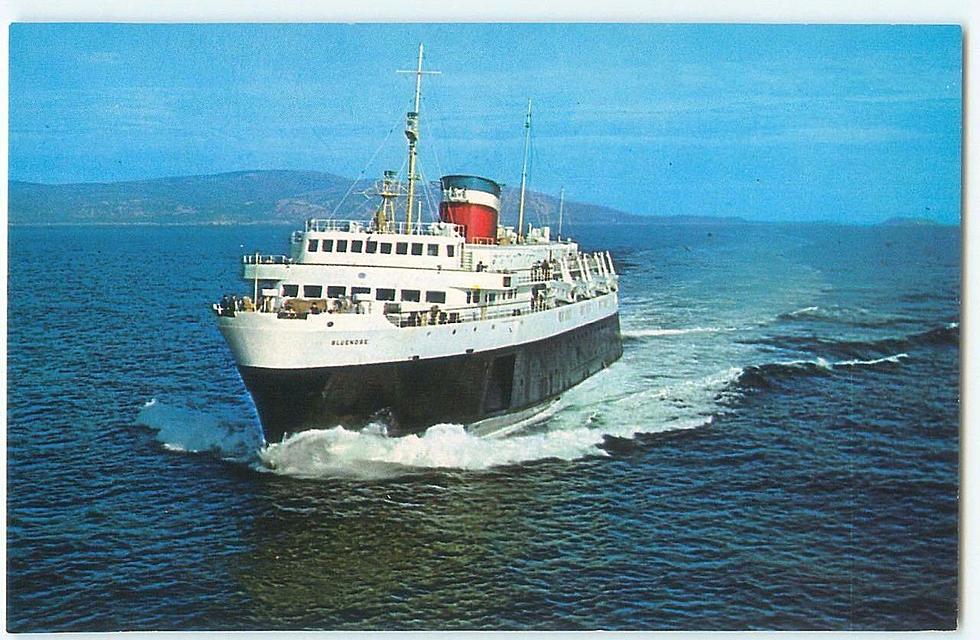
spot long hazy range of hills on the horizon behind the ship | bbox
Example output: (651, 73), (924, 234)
(8, 171), (744, 226)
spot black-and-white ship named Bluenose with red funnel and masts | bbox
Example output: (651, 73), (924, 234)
(212, 45), (623, 443)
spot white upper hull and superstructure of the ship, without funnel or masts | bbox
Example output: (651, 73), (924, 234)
(215, 220), (618, 369)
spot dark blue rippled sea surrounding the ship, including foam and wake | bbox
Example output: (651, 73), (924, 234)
(7, 220), (960, 631)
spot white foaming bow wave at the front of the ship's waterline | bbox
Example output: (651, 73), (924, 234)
(138, 348), (741, 479)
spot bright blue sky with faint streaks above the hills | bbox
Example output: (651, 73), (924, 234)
(9, 24), (962, 222)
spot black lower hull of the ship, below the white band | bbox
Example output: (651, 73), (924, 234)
(239, 314), (623, 442)
